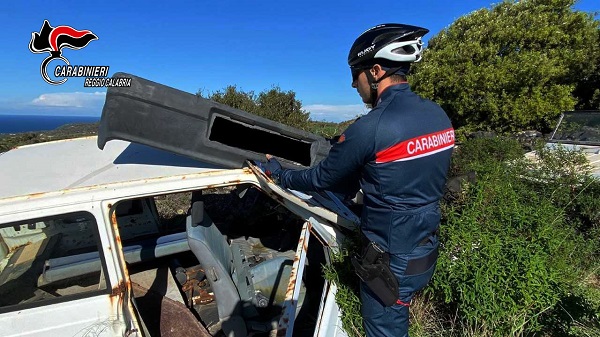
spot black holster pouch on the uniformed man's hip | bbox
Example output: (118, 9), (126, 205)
(352, 242), (398, 307)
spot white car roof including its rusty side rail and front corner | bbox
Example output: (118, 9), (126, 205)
(0, 137), (357, 236)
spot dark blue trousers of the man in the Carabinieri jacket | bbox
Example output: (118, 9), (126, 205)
(360, 235), (439, 337)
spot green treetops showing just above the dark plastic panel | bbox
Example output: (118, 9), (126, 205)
(197, 85), (309, 130)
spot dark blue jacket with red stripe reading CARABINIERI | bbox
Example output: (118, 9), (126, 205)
(280, 84), (454, 254)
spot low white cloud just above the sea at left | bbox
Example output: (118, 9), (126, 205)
(30, 92), (106, 109)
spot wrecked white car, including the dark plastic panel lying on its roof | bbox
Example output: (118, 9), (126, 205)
(0, 73), (359, 337)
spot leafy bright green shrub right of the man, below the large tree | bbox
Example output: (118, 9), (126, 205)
(434, 139), (600, 336)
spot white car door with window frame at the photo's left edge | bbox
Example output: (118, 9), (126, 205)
(0, 204), (138, 337)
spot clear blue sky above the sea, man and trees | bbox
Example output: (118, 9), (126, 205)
(0, 0), (600, 122)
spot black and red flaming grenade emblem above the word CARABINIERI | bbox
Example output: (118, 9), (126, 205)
(29, 20), (98, 85)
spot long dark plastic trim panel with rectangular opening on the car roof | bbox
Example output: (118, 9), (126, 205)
(98, 73), (331, 168)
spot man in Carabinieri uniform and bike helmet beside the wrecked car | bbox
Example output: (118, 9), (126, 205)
(261, 24), (454, 337)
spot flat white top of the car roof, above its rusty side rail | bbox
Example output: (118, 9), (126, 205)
(0, 136), (227, 199)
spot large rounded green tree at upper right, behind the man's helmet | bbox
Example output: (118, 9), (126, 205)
(410, 0), (600, 132)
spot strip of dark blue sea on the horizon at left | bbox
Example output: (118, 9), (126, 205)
(0, 115), (100, 134)
